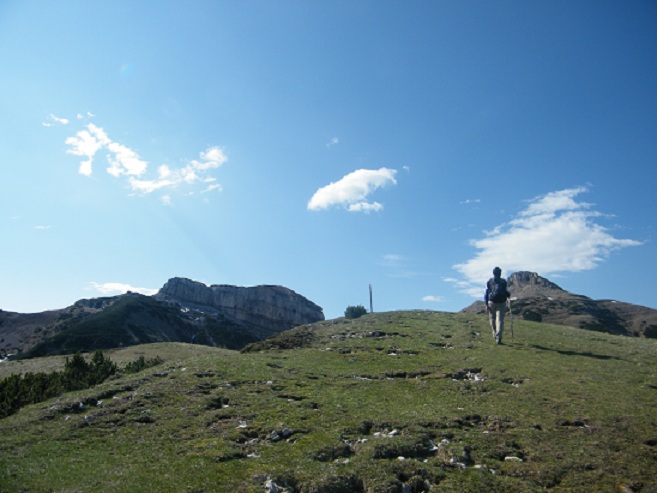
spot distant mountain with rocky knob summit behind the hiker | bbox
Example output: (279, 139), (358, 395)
(462, 271), (657, 338)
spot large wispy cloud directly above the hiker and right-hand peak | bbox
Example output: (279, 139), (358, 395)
(454, 187), (642, 297)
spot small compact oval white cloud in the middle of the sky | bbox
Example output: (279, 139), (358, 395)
(308, 168), (397, 213)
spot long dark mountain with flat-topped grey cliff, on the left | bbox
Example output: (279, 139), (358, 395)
(0, 278), (324, 358)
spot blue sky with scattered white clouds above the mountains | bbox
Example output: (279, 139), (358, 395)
(0, 0), (657, 318)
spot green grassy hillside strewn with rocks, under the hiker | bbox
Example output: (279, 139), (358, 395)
(0, 312), (657, 493)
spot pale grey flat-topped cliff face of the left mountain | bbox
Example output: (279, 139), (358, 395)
(155, 277), (324, 338)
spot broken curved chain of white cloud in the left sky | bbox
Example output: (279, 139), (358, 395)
(60, 113), (228, 199)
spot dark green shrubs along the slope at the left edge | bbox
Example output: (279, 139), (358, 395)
(0, 350), (162, 419)
